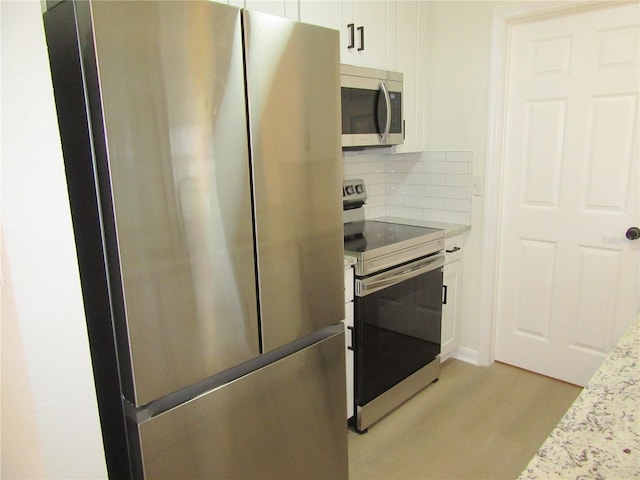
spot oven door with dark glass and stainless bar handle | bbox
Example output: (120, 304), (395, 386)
(354, 254), (444, 406)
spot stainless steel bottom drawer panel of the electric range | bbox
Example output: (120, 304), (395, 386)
(356, 355), (440, 431)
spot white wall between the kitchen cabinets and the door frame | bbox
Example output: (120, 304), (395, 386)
(425, 1), (513, 361)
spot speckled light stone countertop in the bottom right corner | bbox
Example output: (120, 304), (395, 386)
(520, 316), (640, 480)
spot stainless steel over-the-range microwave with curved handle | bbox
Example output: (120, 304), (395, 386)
(340, 64), (404, 149)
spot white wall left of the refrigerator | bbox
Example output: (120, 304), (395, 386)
(0, 0), (107, 479)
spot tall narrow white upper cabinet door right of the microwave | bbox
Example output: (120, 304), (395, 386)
(394, 0), (427, 153)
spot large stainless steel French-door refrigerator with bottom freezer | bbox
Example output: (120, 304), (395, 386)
(45, 0), (348, 479)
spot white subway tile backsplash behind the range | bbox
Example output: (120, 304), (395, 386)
(343, 151), (473, 224)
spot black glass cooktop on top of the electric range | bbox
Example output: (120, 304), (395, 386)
(344, 220), (444, 253)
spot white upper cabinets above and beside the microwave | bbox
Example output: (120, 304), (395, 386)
(215, 0), (428, 153)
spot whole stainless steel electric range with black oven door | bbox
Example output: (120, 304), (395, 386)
(343, 180), (444, 433)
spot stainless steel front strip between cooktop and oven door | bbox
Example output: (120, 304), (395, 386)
(345, 237), (444, 276)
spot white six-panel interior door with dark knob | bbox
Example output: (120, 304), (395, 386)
(495, 4), (640, 385)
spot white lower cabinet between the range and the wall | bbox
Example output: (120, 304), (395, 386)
(440, 236), (463, 361)
